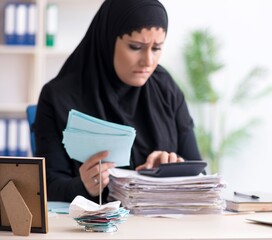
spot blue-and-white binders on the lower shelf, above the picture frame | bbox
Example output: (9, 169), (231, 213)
(0, 118), (29, 157)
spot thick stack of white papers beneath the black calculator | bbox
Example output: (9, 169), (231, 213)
(109, 168), (225, 215)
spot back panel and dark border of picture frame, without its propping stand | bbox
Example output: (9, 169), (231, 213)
(0, 157), (48, 233)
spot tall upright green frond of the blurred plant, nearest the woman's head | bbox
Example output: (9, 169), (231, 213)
(183, 30), (223, 102)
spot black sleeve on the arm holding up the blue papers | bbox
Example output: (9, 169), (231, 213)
(34, 84), (106, 202)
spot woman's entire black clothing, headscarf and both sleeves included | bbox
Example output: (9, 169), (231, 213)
(35, 0), (201, 201)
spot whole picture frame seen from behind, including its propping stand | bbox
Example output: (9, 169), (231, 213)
(0, 156), (48, 233)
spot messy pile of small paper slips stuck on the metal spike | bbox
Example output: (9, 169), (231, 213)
(69, 196), (129, 232)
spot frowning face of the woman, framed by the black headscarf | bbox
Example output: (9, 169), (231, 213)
(113, 28), (166, 87)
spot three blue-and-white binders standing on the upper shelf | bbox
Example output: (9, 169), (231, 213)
(4, 1), (37, 45)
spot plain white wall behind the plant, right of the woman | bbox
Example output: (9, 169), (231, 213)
(161, 0), (272, 191)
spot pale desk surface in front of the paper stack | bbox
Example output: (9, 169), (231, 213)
(0, 213), (272, 240)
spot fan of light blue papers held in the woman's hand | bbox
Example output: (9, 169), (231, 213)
(63, 110), (136, 166)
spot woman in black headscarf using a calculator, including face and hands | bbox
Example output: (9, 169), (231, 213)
(35, 0), (201, 202)
